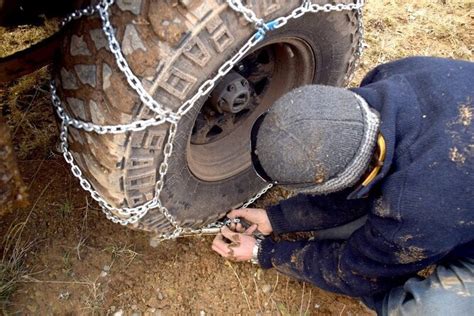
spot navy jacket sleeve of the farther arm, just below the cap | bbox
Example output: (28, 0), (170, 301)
(267, 190), (368, 234)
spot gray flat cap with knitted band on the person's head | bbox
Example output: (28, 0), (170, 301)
(252, 85), (380, 194)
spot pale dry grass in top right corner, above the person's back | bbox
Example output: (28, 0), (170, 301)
(353, 0), (474, 85)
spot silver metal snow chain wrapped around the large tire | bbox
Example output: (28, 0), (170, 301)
(51, 0), (364, 240)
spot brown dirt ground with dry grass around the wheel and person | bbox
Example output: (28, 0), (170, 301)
(0, 0), (474, 315)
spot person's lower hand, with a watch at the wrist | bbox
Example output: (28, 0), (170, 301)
(212, 225), (257, 261)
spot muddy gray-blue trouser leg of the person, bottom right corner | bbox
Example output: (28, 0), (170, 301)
(381, 258), (474, 316)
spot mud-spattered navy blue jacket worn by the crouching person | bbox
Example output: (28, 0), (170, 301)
(259, 57), (474, 307)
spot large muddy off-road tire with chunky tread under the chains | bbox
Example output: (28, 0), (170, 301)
(56, 0), (358, 232)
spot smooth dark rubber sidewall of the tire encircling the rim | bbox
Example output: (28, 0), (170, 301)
(137, 6), (355, 227)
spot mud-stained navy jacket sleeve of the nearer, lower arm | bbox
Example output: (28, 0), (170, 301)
(259, 217), (444, 299)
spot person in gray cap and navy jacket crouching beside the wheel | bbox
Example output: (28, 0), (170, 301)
(213, 57), (474, 315)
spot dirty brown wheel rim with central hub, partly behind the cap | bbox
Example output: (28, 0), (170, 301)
(186, 37), (316, 181)
